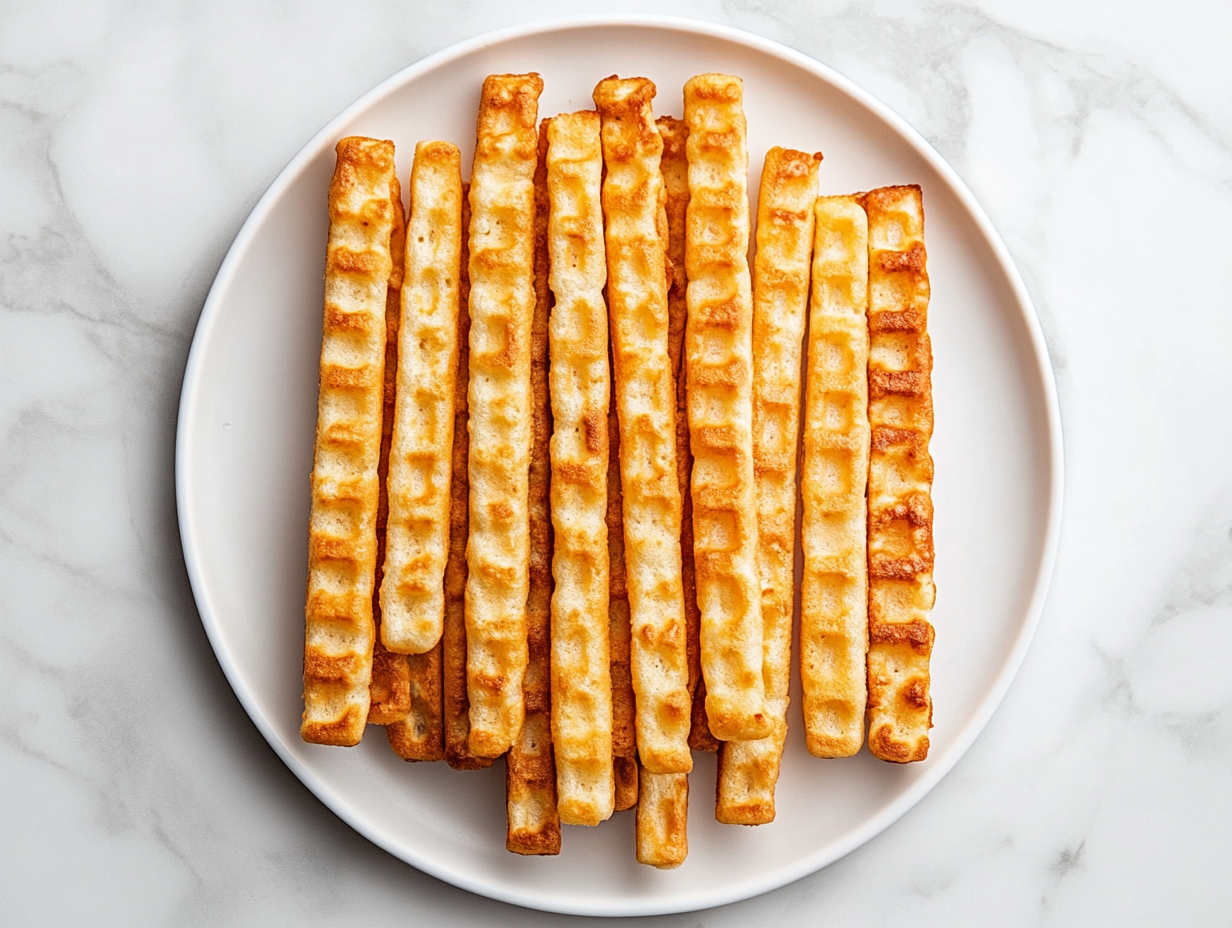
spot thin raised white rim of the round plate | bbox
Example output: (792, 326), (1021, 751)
(175, 14), (1064, 917)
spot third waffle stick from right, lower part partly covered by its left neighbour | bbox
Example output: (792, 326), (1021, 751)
(715, 148), (821, 824)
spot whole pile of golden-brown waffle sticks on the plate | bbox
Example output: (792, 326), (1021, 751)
(302, 68), (934, 868)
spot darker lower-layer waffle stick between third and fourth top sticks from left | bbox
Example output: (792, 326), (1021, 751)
(505, 120), (561, 854)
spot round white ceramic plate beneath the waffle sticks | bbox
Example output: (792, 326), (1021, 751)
(176, 17), (1061, 916)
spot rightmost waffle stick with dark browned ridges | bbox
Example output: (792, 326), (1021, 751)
(864, 186), (936, 763)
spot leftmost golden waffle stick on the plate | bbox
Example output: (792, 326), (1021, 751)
(299, 137), (395, 746)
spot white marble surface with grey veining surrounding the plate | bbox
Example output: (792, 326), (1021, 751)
(0, 0), (1232, 927)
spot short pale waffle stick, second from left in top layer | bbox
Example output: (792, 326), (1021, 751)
(381, 142), (462, 654)
